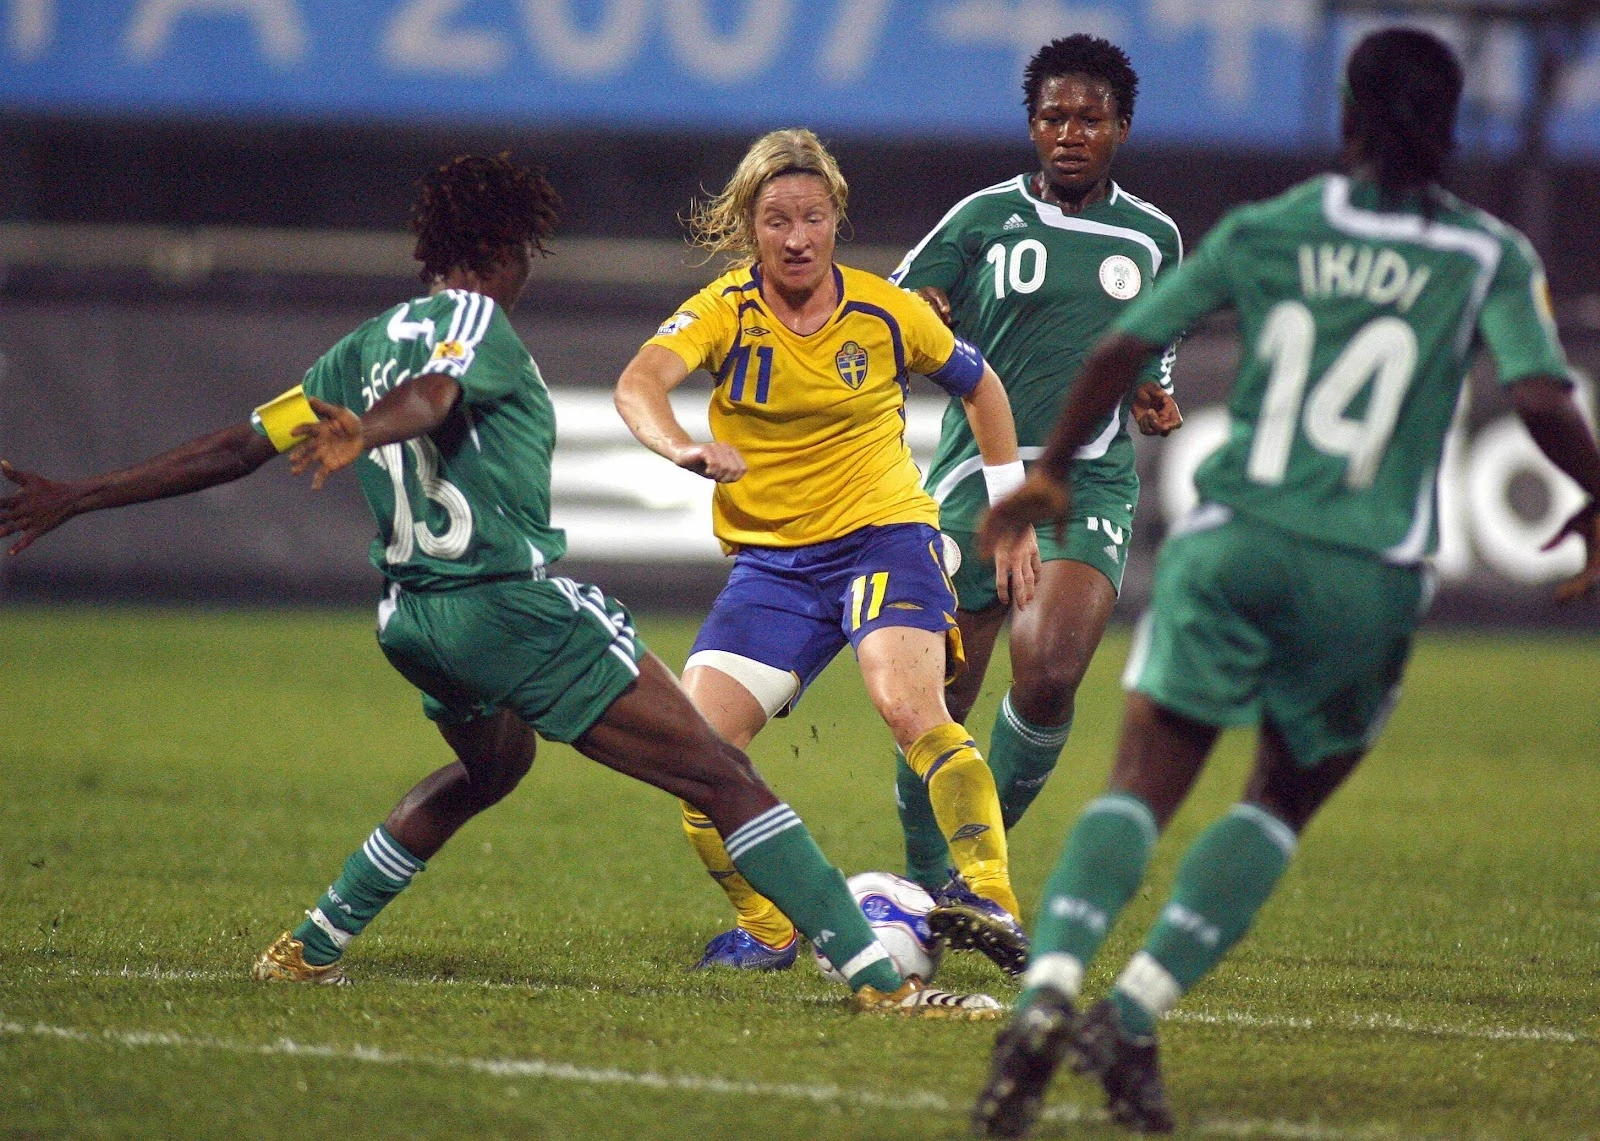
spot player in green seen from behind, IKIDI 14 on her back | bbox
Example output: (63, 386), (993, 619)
(974, 29), (1600, 1136)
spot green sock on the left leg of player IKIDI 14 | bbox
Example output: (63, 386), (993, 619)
(1022, 792), (1158, 1000)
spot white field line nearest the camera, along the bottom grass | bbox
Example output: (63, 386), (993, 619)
(0, 1016), (1472, 1141)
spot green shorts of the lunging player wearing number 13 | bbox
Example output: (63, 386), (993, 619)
(378, 578), (645, 741)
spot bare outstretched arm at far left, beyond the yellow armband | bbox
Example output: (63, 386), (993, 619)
(0, 422), (277, 555)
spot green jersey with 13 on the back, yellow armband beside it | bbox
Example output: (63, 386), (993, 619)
(258, 290), (566, 591)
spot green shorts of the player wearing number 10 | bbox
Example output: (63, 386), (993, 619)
(939, 467), (1139, 611)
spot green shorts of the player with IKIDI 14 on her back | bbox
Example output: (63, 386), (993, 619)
(1123, 504), (1427, 768)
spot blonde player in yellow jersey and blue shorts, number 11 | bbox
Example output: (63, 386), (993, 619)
(616, 130), (1038, 971)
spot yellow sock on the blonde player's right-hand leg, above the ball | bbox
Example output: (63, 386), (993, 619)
(906, 722), (1022, 919)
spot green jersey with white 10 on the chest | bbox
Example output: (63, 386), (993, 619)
(890, 174), (1182, 525)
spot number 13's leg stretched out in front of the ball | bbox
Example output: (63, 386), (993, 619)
(574, 653), (1002, 1018)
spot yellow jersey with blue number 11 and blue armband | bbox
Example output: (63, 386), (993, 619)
(648, 266), (984, 549)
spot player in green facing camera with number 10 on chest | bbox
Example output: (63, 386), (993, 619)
(890, 35), (1182, 888)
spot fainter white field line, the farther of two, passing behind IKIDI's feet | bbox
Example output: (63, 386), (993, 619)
(24, 967), (1595, 1045)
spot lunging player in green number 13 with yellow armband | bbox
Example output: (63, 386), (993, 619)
(0, 155), (998, 1018)
